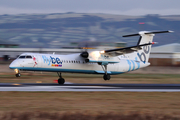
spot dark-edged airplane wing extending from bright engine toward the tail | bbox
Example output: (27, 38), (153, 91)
(101, 43), (152, 56)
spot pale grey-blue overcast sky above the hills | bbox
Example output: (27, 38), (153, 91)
(0, 0), (180, 16)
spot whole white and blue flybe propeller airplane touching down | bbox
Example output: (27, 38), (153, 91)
(9, 31), (173, 85)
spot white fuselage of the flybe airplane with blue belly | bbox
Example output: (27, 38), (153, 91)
(9, 53), (149, 74)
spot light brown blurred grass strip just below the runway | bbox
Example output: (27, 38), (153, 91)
(0, 92), (180, 115)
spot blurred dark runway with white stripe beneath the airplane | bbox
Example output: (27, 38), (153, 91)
(0, 83), (180, 92)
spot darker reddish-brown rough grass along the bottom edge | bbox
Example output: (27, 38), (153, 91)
(0, 112), (180, 120)
